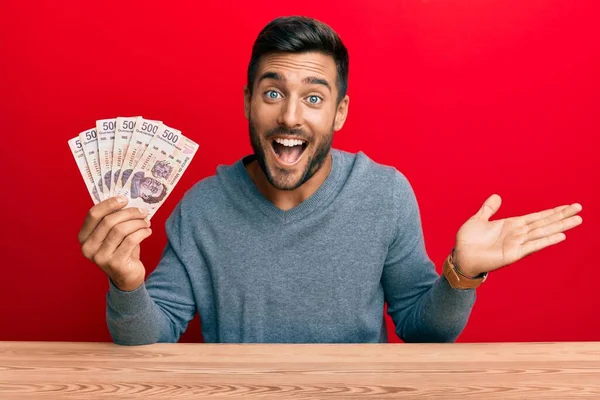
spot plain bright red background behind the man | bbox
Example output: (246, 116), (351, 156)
(0, 0), (600, 342)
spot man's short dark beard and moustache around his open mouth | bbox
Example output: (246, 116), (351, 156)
(248, 119), (333, 190)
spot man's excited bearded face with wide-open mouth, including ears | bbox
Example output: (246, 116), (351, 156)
(245, 52), (349, 190)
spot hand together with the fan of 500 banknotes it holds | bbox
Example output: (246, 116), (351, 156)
(69, 117), (198, 291)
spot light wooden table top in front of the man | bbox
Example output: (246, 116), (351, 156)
(0, 342), (600, 400)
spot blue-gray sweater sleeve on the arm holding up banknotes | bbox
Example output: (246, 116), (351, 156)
(106, 204), (196, 345)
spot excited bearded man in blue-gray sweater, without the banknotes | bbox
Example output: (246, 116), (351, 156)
(79, 17), (581, 345)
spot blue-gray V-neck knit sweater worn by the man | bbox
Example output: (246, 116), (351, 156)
(107, 149), (475, 345)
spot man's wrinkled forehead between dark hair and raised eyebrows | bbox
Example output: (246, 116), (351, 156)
(256, 52), (337, 84)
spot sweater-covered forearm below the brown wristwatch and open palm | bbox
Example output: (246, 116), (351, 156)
(398, 276), (475, 342)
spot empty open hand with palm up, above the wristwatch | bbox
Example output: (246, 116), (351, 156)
(454, 195), (582, 276)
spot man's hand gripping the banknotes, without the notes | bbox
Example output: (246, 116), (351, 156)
(78, 196), (152, 291)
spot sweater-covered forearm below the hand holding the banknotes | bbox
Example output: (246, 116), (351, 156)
(106, 281), (179, 345)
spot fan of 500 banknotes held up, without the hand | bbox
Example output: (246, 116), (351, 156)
(69, 117), (198, 218)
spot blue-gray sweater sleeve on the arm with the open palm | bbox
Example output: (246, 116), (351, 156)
(382, 171), (475, 342)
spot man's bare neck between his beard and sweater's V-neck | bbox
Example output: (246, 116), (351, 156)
(246, 152), (332, 211)
